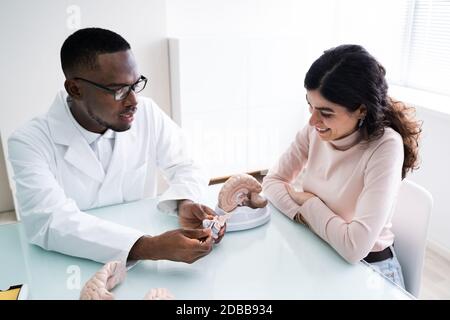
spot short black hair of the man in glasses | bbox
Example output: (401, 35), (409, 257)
(61, 28), (130, 77)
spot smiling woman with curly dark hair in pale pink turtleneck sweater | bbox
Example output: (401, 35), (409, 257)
(263, 45), (421, 286)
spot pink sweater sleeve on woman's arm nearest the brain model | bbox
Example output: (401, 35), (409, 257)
(262, 125), (309, 219)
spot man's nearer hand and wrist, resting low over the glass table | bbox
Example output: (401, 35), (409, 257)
(128, 229), (213, 263)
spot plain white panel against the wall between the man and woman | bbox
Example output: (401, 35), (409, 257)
(169, 36), (307, 178)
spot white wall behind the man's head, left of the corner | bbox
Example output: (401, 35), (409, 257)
(0, 0), (170, 212)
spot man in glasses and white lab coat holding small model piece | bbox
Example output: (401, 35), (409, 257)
(8, 28), (224, 263)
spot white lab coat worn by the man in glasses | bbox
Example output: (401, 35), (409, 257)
(8, 91), (208, 263)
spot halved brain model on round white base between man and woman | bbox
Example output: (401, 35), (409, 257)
(219, 173), (267, 212)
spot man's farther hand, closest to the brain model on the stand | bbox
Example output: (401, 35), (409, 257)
(178, 200), (226, 243)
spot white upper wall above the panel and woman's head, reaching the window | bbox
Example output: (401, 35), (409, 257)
(167, 0), (409, 75)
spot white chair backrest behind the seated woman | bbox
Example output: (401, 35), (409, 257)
(392, 180), (433, 297)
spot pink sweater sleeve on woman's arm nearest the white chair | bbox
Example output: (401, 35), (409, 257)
(300, 136), (404, 263)
